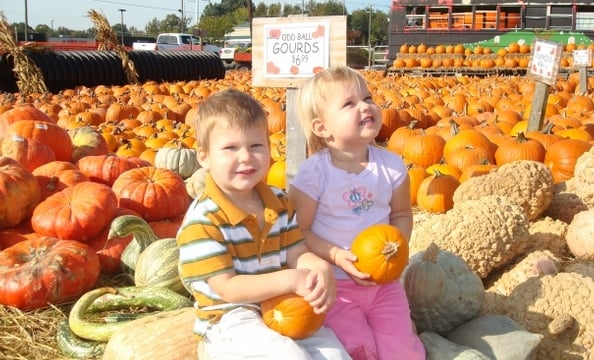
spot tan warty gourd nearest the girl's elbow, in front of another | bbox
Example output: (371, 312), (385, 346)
(409, 195), (530, 279)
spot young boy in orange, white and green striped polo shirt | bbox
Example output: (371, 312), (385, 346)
(177, 89), (350, 360)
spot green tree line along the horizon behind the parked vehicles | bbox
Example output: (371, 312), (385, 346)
(11, 0), (388, 46)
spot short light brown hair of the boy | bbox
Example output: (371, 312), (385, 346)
(195, 89), (268, 150)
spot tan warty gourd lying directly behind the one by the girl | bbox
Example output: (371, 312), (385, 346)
(453, 160), (554, 220)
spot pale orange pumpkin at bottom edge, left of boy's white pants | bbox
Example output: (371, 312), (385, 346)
(103, 307), (198, 360)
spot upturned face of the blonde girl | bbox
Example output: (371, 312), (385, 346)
(313, 84), (382, 149)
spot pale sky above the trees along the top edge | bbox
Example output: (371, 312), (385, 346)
(0, 0), (391, 30)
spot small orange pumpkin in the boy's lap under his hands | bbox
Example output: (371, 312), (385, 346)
(260, 293), (325, 340)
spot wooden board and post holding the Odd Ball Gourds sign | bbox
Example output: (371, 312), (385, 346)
(252, 16), (346, 186)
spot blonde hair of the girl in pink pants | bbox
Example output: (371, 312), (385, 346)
(296, 66), (367, 154)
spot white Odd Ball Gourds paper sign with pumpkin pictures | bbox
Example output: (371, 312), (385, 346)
(264, 22), (330, 78)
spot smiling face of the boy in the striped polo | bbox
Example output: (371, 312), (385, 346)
(198, 119), (270, 197)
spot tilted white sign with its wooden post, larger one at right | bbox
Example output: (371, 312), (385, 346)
(527, 39), (563, 131)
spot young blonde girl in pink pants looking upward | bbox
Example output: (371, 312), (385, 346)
(289, 67), (425, 360)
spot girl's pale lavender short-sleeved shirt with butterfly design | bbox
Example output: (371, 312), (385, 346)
(291, 145), (410, 279)
